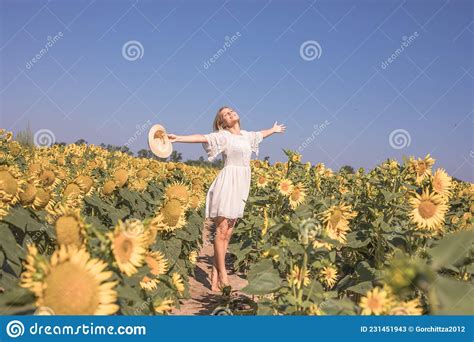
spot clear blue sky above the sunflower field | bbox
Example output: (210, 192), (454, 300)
(0, 0), (474, 182)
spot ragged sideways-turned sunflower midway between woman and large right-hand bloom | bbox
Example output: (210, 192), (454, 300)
(321, 203), (357, 243)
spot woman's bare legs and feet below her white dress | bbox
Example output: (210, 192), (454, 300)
(212, 217), (229, 291)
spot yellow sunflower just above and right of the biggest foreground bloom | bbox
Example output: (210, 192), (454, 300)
(108, 220), (146, 276)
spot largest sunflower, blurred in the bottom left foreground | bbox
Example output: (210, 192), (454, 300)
(21, 245), (119, 315)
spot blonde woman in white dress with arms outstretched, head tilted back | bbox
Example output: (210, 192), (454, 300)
(168, 107), (286, 291)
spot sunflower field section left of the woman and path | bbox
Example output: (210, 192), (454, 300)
(0, 130), (211, 315)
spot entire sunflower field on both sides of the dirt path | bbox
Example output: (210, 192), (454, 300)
(0, 130), (474, 315)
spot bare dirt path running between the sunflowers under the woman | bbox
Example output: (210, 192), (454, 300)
(172, 221), (247, 315)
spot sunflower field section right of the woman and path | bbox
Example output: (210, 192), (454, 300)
(229, 151), (474, 315)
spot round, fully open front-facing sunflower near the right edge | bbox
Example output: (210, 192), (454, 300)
(409, 189), (449, 230)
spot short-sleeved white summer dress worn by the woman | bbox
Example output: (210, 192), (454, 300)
(202, 129), (263, 219)
